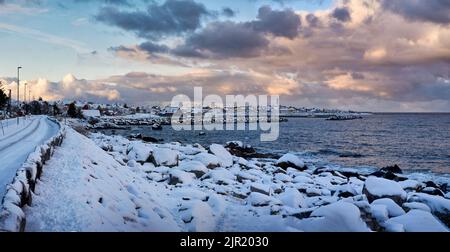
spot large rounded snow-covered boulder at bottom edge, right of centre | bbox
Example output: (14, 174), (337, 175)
(297, 201), (370, 232)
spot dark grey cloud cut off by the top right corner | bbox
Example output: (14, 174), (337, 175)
(381, 0), (450, 24)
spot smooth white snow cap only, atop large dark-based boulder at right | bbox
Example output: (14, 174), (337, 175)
(364, 176), (406, 199)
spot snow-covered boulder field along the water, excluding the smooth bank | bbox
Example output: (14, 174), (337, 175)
(90, 133), (450, 232)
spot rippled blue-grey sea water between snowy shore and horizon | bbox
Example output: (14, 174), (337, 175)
(102, 114), (450, 174)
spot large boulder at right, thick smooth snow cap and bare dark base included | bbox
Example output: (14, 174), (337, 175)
(363, 176), (406, 205)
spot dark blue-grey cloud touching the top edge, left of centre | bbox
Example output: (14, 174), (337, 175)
(96, 0), (212, 39)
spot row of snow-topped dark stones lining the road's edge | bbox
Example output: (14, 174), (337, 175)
(0, 117), (66, 232)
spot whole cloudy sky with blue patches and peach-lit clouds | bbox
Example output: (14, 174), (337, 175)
(0, 0), (450, 112)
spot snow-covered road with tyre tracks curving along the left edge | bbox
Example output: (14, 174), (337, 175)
(0, 116), (59, 199)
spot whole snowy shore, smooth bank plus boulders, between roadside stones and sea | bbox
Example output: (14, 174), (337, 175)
(25, 129), (450, 232)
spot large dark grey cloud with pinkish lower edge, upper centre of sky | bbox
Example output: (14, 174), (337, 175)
(172, 6), (301, 58)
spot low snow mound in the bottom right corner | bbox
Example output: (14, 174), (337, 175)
(387, 210), (448, 232)
